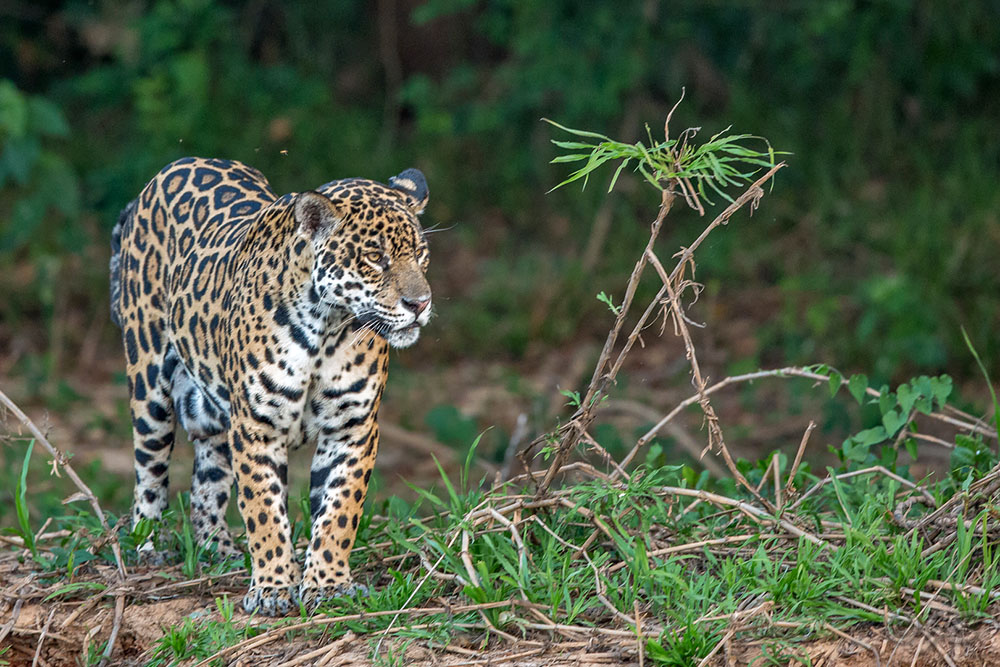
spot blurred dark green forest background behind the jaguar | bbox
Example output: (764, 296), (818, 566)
(0, 0), (1000, 490)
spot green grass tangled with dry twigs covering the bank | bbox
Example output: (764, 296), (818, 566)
(5, 420), (1000, 665)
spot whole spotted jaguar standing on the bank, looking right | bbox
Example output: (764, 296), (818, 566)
(111, 158), (431, 615)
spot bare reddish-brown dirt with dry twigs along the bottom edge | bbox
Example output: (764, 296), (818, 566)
(0, 591), (1000, 667)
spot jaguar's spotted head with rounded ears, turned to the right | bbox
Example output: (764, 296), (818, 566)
(294, 169), (431, 347)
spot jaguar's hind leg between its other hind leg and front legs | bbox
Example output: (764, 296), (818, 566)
(191, 432), (243, 558)
